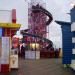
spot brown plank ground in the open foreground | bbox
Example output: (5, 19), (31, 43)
(0, 59), (75, 75)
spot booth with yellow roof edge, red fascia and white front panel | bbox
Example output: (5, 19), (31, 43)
(0, 23), (20, 73)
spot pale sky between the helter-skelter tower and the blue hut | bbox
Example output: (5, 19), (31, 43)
(46, 0), (74, 47)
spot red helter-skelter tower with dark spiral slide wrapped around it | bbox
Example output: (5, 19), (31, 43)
(22, 0), (53, 58)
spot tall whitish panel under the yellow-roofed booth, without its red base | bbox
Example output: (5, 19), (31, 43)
(1, 37), (10, 64)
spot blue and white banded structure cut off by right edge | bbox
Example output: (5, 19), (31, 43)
(70, 5), (75, 70)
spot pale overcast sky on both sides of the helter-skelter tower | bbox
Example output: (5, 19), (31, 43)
(0, 0), (74, 47)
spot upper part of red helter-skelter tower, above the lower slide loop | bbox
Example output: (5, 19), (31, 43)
(28, 0), (52, 47)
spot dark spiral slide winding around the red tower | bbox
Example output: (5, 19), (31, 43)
(21, 4), (53, 50)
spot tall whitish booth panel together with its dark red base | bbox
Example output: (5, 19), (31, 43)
(0, 37), (10, 72)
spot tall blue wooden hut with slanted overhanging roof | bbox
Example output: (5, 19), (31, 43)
(56, 21), (73, 64)
